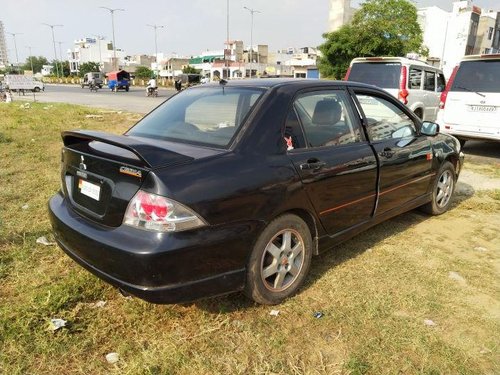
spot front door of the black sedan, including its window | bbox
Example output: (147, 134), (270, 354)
(353, 88), (434, 215)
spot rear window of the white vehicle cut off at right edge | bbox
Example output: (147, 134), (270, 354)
(451, 60), (500, 92)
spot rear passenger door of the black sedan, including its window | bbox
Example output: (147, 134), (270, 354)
(285, 88), (377, 234)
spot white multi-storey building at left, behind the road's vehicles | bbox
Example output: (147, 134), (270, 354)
(68, 37), (126, 73)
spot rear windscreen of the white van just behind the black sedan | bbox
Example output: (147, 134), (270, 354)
(347, 62), (401, 89)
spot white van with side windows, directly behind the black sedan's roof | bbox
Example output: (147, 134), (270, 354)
(345, 57), (446, 121)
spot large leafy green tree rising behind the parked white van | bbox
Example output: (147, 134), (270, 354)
(319, 0), (426, 79)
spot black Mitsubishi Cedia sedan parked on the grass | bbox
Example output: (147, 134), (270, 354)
(49, 79), (463, 304)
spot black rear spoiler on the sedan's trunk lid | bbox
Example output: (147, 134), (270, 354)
(61, 130), (193, 168)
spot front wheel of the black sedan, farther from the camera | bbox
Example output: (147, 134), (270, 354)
(422, 161), (456, 215)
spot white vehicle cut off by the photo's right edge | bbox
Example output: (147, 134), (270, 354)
(437, 54), (500, 145)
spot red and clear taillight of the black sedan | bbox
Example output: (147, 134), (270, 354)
(123, 190), (207, 232)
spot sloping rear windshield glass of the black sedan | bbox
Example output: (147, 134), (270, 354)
(127, 86), (264, 147)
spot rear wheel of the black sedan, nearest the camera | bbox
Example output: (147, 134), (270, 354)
(245, 214), (313, 305)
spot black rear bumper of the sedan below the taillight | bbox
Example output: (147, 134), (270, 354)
(49, 194), (261, 303)
